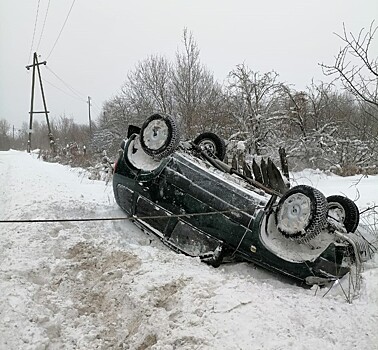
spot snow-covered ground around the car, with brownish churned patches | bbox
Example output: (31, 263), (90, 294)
(0, 151), (378, 350)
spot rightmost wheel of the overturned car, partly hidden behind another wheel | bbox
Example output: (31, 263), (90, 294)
(327, 195), (360, 232)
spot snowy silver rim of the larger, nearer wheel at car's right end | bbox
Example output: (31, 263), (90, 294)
(278, 193), (311, 235)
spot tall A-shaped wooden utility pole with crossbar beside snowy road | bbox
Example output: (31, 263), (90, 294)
(26, 52), (56, 153)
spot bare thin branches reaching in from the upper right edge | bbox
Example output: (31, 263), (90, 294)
(321, 21), (378, 113)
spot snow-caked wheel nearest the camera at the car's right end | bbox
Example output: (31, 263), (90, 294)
(276, 185), (328, 243)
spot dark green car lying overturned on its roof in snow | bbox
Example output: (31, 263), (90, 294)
(113, 114), (370, 285)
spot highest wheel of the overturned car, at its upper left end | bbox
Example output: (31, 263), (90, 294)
(140, 113), (180, 159)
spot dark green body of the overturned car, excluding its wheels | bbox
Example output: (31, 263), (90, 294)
(113, 134), (358, 281)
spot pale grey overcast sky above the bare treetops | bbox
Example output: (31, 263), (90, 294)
(0, 0), (378, 128)
